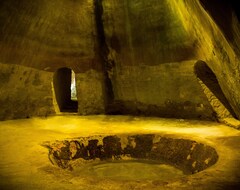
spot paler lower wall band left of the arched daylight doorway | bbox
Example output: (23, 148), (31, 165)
(0, 64), (54, 120)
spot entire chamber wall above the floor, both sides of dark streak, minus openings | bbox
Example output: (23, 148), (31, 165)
(0, 0), (240, 120)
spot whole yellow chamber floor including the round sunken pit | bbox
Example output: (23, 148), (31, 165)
(0, 116), (240, 190)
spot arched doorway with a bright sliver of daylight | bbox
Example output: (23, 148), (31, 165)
(53, 68), (78, 112)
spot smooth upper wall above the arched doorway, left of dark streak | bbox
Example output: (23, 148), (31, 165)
(0, 0), (99, 72)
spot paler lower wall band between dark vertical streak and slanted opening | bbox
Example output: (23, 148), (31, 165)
(106, 61), (214, 119)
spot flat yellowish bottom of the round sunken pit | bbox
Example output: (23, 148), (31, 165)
(75, 161), (185, 180)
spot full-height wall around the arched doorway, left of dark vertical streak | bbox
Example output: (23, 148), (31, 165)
(0, 0), (104, 120)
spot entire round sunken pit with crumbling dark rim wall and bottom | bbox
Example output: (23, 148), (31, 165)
(44, 134), (218, 180)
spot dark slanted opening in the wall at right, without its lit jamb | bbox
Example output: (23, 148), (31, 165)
(194, 61), (236, 117)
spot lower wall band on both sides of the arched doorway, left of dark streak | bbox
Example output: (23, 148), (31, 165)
(0, 64), (105, 120)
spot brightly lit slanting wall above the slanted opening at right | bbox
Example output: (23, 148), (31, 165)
(169, 0), (240, 118)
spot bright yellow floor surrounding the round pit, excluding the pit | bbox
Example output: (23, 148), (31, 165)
(0, 115), (240, 190)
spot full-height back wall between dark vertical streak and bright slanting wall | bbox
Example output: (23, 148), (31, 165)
(102, 0), (216, 118)
